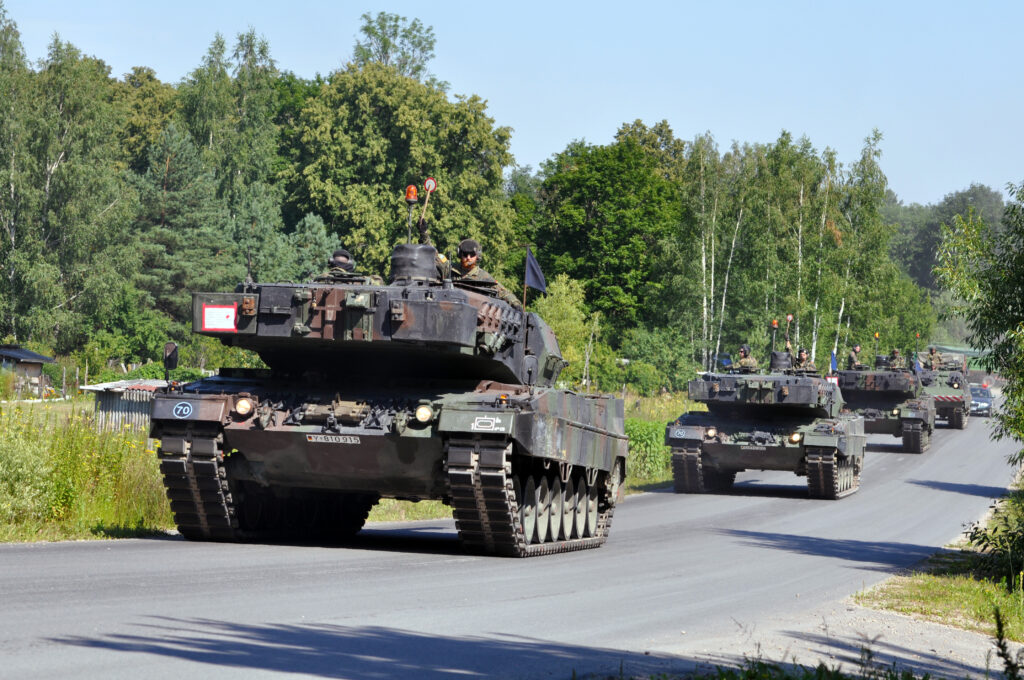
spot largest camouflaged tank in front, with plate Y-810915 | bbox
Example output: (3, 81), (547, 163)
(151, 244), (628, 557)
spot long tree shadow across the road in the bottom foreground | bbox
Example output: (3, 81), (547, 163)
(53, 618), (694, 680)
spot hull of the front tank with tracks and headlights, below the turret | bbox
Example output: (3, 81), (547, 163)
(152, 377), (628, 556)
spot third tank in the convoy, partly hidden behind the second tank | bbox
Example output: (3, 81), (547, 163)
(838, 354), (936, 454)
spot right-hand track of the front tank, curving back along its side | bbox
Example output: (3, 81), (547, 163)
(446, 437), (614, 557)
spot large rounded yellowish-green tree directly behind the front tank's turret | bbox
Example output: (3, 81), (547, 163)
(286, 63), (515, 276)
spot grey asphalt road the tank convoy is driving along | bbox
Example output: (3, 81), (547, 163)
(0, 418), (1015, 680)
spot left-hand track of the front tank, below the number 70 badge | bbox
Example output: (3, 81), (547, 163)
(157, 430), (240, 541)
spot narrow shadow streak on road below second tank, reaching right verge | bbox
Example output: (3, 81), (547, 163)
(719, 529), (936, 572)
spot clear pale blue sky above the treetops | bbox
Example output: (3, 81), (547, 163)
(2, 0), (1024, 203)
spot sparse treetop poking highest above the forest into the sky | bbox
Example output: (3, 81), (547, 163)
(352, 12), (445, 89)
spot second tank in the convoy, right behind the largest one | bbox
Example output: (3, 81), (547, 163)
(665, 352), (865, 500)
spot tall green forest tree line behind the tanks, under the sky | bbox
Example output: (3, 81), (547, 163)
(0, 4), (985, 392)
